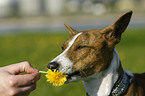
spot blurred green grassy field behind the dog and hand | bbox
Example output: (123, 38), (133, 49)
(0, 29), (145, 96)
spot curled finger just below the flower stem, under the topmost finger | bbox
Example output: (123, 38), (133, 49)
(8, 72), (40, 87)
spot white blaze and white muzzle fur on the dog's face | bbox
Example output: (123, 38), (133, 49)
(51, 32), (82, 74)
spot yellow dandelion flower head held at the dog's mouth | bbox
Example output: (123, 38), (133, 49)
(39, 69), (68, 87)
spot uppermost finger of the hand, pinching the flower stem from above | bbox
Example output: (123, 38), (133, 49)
(5, 61), (38, 74)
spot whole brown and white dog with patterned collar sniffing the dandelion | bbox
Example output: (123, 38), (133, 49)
(47, 11), (145, 96)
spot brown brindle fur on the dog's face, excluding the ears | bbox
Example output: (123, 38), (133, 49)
(62, 29), (114, 77)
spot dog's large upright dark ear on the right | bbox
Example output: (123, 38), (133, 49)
(102, 11), (132, 44)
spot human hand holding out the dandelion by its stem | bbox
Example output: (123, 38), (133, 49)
(0, 62), (40, 96)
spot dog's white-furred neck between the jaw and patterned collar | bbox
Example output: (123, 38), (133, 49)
(84, 49), (120, 96)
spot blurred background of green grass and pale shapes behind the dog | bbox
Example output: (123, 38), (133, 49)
(0, 0), (145, 96)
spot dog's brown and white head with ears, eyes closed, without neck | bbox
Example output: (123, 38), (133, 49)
(48, 11), (132, 82)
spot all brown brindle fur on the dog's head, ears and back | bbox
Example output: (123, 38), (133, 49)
(51, 11), (145, 96)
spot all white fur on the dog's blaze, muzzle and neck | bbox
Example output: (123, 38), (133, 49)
(51, 33), (133, 96)
